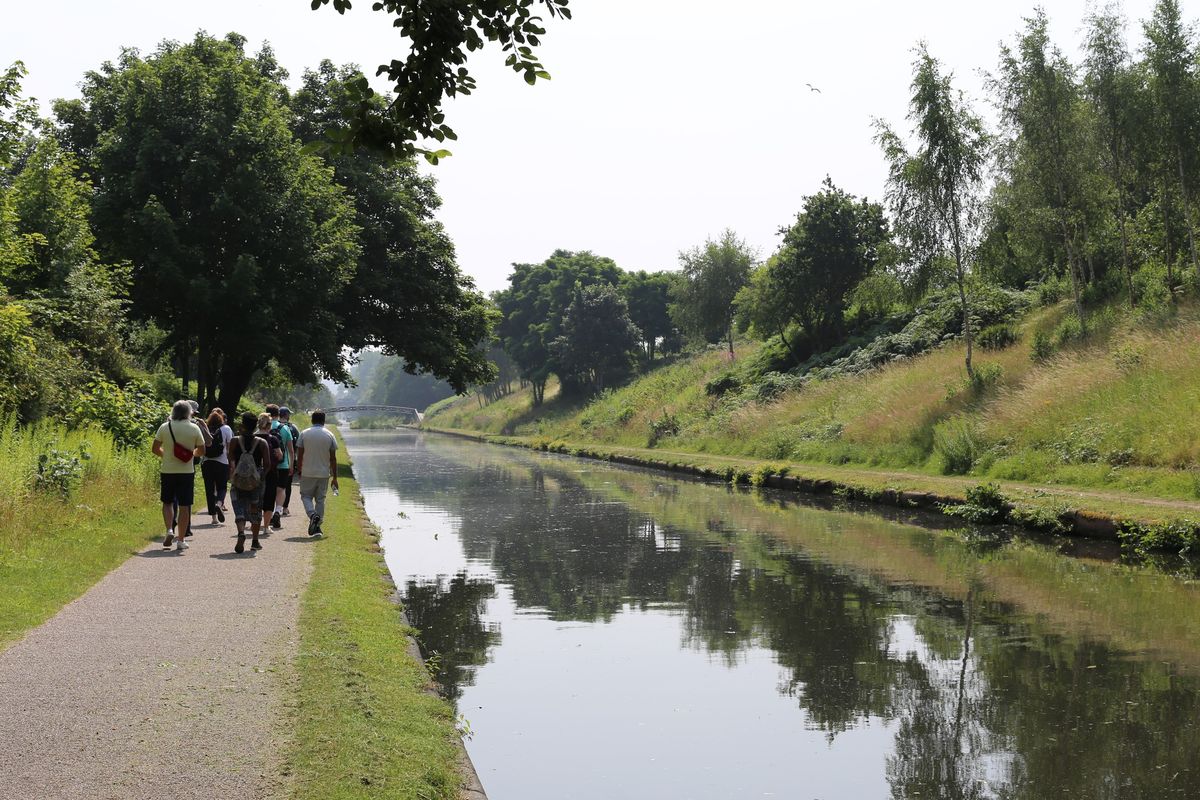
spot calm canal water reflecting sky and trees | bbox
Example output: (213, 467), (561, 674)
(347, 432), (1200, 800)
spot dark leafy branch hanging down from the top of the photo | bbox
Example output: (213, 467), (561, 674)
(311, 0), (571, 163)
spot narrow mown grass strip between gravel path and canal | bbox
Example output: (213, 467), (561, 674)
(288, 429), (462, 800)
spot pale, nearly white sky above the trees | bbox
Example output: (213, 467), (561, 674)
(0, 0), (1161, 291)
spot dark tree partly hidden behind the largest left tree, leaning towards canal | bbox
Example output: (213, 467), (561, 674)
(290, 61), (494, 391)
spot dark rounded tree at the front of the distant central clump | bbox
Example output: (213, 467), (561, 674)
(552, 284), (644, 393)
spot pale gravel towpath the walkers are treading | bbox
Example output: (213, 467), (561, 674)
(0, 510), (319, 800)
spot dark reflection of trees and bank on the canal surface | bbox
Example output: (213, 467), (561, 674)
(381, 441), (1200, 800)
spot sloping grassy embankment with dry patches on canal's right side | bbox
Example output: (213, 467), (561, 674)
(426, 303), (1200, 537)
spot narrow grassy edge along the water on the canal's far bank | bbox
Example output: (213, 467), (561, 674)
(420, 425), (1200, 551)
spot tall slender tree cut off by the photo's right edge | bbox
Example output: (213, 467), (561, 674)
(1145, 0), (1200, 276)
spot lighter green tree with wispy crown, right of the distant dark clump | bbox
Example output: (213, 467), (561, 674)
(671, 230), (756, 356)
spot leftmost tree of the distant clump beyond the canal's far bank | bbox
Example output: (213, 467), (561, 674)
(496, 249), (622, 405)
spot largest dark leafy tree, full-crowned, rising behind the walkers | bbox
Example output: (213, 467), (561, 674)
(55, 34), (358, 409)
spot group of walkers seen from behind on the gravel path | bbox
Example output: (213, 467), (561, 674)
(152, 401), (337, 553)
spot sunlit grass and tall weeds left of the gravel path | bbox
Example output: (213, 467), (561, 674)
(0, 422), (162, 649)
